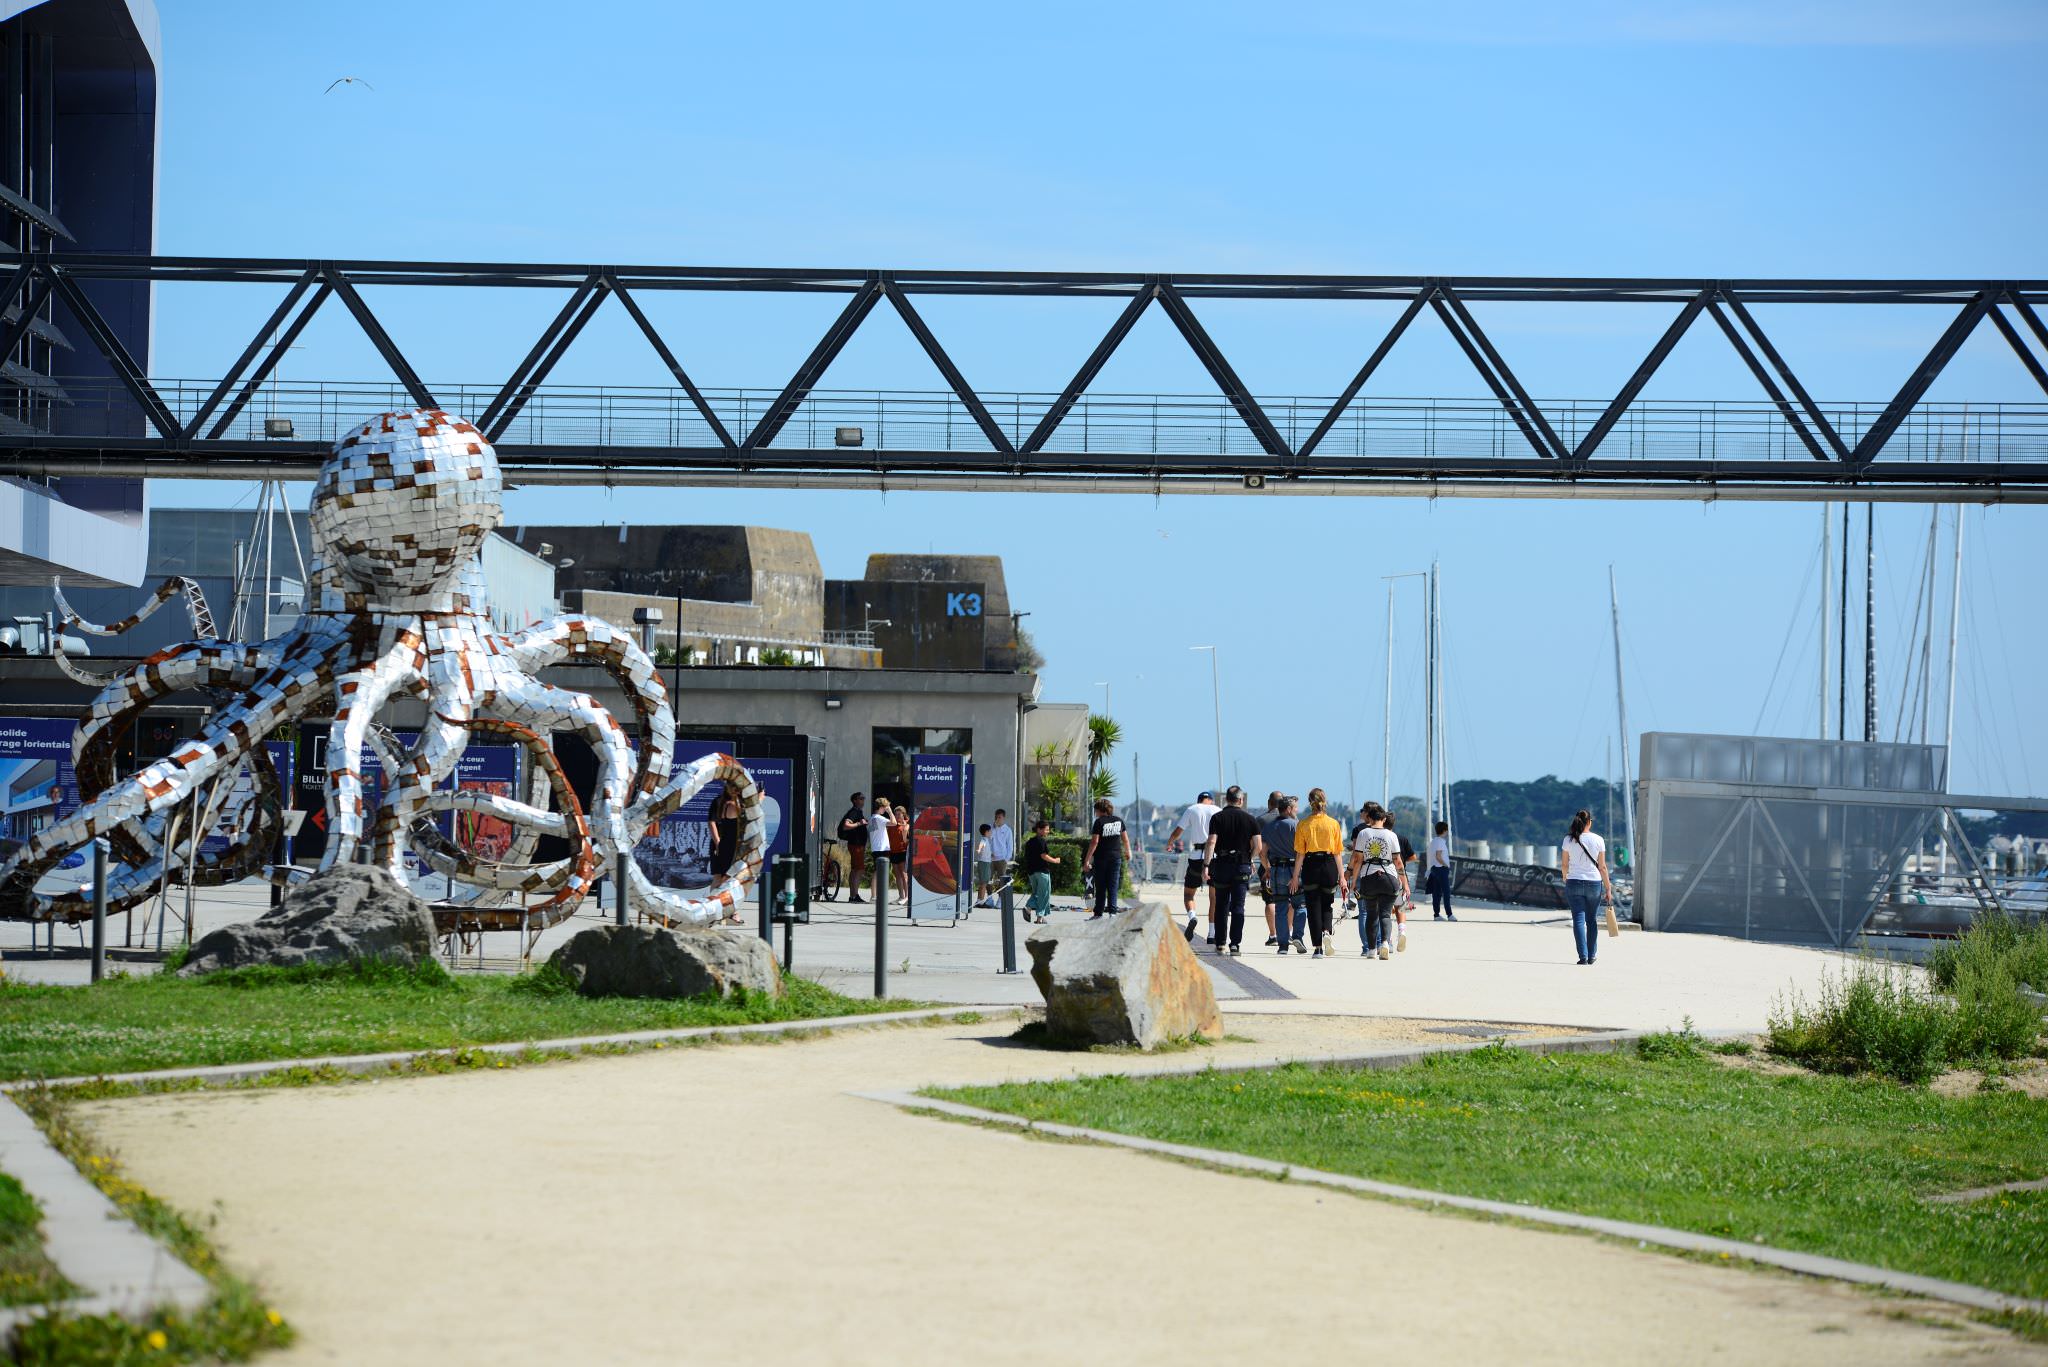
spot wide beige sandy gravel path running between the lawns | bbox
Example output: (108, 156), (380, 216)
(82, 1017), (2048, 1367)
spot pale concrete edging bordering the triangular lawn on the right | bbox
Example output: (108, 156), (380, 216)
(854, 1031), (2048, 1314)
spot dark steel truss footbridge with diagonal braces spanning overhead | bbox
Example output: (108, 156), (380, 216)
(0, 252), (2048, 498)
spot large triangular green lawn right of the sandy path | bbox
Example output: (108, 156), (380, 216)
(932, 1043), (2048, 1297)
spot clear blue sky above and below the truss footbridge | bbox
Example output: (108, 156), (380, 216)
(152, 0), (2048, 799)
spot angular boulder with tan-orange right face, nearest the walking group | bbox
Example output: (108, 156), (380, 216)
(1024, 906), (1223, 1049)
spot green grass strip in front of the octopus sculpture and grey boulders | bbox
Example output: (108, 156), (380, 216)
(0, 963), (915, 1080)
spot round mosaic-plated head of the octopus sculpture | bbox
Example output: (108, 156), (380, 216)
(311, 408), (504, 611)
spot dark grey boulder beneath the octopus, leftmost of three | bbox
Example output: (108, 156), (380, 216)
(178, 865), (434, 978)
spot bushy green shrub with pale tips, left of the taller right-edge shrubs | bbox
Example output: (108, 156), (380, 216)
(1765, 967), (1956, 1084)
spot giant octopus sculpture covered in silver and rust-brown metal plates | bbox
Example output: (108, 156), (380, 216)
(0, 410), (764, 935)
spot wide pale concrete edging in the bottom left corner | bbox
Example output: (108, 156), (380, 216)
(0, 1101), (213, 1342)
